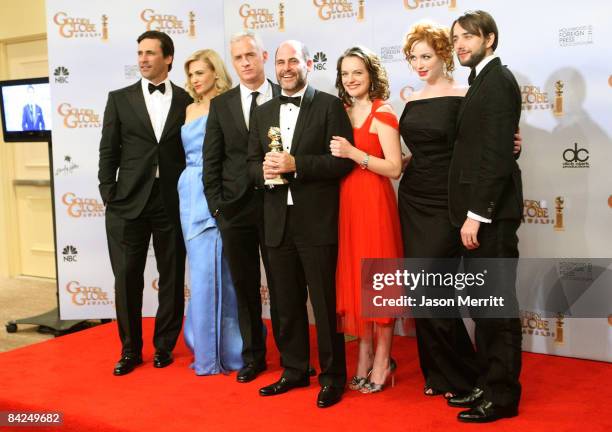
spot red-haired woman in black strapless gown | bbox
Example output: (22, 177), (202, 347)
(398, 23), (520, 399)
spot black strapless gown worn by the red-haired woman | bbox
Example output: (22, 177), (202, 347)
(398, 96), (477, 393)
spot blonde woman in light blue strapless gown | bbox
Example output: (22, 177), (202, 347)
(178, 49), (242, 375)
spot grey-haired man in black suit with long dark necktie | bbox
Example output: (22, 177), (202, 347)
(203, 31), (280, 383)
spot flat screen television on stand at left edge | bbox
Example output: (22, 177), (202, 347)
(0, 78), (51, 142)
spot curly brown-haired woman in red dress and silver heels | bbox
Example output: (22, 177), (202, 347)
(330, 47), (403, 393)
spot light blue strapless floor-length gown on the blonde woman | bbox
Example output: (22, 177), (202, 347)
(178, 116), (242, 375)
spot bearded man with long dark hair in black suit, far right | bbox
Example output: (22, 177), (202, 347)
(449, 11), (523, 422)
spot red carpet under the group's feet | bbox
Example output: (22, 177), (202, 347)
(0, 319), (612, 432)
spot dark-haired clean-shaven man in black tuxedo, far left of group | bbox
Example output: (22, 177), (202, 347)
(98, 31), (191, 375)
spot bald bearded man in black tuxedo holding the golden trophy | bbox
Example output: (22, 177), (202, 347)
(249, 41), (353, 408)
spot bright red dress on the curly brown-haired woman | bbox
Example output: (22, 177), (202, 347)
(336, 99), (403, 336)
